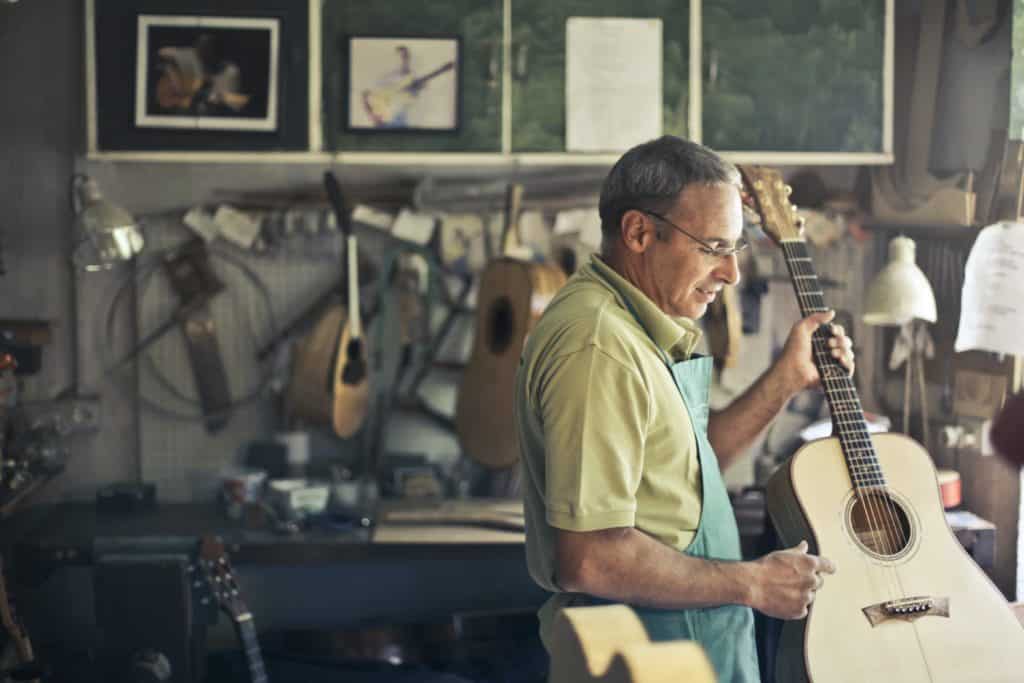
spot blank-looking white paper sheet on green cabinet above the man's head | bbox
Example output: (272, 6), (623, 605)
(565, 16), (662, 152)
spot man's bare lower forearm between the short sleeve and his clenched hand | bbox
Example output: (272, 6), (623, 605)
(559, 528), (755, 609)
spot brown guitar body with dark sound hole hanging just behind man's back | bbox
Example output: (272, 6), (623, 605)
(455, 258), (565, 468)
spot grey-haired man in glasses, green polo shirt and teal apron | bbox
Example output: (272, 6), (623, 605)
(515, 136), (854, 682)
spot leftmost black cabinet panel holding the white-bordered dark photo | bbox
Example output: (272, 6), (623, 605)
(89, 0), (309, 153)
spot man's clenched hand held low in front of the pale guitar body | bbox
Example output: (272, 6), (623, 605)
(751, 541), (836, 618)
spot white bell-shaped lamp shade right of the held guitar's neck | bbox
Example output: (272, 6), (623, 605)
(862, 237), (937, 325)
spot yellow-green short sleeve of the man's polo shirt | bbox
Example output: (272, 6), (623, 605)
(535, 345), (650, 531)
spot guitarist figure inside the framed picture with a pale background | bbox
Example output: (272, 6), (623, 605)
(359, 44), (455, 128)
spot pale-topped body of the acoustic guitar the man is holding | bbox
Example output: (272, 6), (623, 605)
(768, 434), (1024, 683)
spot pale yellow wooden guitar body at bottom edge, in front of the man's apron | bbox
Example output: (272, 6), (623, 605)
(548, 605), (715, 683)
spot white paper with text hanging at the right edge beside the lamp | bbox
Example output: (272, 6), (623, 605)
(953, 221), (1024, 354)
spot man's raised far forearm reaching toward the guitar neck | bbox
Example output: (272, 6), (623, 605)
(708, 366), (797, 470)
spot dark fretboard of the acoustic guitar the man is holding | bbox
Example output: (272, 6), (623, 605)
(782, 240), (886, 489)
